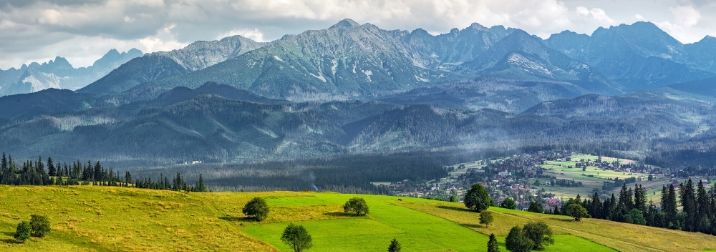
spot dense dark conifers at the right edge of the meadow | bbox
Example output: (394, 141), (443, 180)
(552, 179), (716, 235)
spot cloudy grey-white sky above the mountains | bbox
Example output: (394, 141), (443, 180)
(0, 0), (716, 69)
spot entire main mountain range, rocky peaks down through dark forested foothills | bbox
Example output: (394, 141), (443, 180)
(0, 19), (716, 168)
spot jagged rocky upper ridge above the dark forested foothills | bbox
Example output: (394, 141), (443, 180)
(75, 19), (716, 101)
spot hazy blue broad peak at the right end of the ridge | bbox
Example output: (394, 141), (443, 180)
(546, 22), (714, 91)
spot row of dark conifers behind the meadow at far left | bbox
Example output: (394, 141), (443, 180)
(0, 153), (207, 192)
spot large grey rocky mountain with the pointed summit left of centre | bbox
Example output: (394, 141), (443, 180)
(147, 20), (442, 100)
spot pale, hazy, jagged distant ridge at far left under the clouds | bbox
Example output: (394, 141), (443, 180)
(0, 49), (142, 96)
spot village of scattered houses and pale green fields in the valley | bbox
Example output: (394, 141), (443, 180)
(374, 151), (684, 209)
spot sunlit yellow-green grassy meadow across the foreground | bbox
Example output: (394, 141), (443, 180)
(0, 186), (716, 251)
